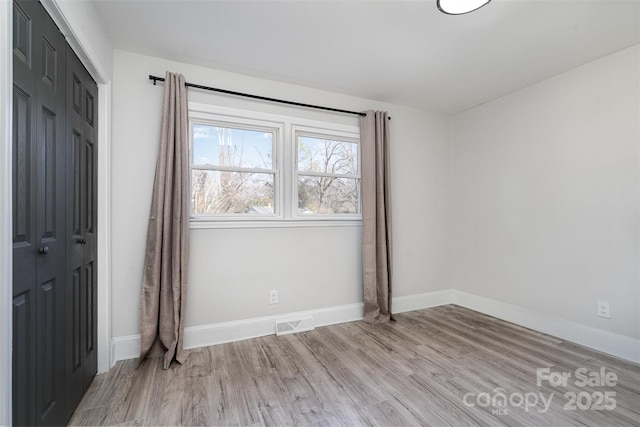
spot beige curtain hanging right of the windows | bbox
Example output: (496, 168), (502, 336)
(360, 111), (392, 323)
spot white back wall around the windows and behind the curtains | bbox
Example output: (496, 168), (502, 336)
(111, 51), (450, 338)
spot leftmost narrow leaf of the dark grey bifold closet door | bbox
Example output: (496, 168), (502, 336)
(12, 0), (38, 425)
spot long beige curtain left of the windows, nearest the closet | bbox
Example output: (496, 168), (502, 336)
(139, 72), (191, 369)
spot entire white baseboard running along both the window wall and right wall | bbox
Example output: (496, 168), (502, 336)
(111, 289), (640, 363)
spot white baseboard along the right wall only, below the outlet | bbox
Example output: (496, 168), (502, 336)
(451, 290), (640, 363)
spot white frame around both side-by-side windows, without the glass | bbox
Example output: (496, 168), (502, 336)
(189, 102), (362, 229)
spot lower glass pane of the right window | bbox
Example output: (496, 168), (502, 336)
(298, 175), (359, 214)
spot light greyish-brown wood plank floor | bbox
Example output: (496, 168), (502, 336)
(70, 305), (640, 426)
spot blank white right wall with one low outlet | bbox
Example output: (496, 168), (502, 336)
(452, 46), (640, 338)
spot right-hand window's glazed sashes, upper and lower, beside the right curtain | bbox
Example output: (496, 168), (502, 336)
(295, 130), (360, 217)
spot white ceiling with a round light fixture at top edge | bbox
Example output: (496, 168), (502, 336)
(93, 0), (640, 114)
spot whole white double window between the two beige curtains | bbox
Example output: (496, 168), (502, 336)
(189, 103), (360, 228)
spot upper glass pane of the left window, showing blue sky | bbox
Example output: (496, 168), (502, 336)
(192, 124), (273, 169)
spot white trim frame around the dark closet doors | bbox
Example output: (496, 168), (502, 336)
(0, 0), (114, 425)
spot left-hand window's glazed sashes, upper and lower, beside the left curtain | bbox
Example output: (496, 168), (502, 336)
(191, 122), (279, 217)
